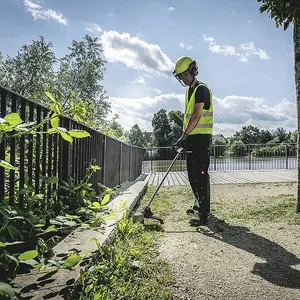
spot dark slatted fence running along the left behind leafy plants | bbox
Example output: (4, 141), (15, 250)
(0, 86), (144, 208)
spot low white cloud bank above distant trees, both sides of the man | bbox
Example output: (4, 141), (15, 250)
(110, 94), (297, 136)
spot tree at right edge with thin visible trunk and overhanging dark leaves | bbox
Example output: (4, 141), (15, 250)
(257, 0), (300, 213)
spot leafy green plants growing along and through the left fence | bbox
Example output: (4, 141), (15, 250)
(0, 93), (113, 297)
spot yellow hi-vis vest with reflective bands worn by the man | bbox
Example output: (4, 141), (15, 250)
(183, 83), (213, 135)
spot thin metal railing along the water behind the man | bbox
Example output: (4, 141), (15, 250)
(142, 143), (297, 174)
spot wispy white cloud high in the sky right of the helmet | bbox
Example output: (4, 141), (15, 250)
(203, 35), (270, 63)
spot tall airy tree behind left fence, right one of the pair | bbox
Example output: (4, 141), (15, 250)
(56, 35), (110, 119)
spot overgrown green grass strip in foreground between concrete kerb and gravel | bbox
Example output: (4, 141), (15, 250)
(74, 219), (176, 300)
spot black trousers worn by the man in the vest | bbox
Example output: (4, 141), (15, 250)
(186, 134), (212, 214)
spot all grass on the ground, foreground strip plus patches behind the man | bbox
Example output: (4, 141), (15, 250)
(74, 184), (300, 300)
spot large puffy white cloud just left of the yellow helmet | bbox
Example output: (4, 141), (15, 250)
(100, 31), (174, 76)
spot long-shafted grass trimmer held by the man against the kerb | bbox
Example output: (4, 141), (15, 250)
(133, 148), (183, 224)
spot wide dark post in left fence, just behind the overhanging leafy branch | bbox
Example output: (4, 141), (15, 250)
(59, 118), (72, 183)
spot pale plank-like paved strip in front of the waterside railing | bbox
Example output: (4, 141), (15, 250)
(149, 169), (297, 186)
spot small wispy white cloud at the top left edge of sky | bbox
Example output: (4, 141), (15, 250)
(23, 0), (67, 25)
